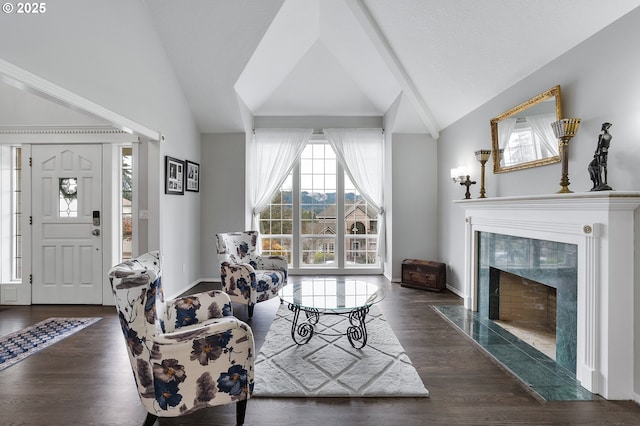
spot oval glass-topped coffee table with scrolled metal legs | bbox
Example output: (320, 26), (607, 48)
(279, 278), (384, 349)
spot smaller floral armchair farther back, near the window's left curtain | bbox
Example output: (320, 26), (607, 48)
(216, 231), (288, 318)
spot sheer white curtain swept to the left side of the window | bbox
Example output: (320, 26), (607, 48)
(247, 129), (313, 231)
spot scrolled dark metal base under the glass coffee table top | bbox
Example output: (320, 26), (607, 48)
(287, 303), (369, 349)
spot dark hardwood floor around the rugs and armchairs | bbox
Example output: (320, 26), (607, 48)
(0, 277), (640, 426)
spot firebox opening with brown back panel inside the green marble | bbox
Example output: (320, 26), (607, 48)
(489, 269), (557, 360)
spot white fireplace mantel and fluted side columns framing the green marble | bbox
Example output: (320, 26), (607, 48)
(454, 191), (640, 401)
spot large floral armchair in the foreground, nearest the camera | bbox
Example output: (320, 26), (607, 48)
(109, 252), (255, 426)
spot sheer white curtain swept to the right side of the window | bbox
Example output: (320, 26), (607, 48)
(323, 129), (386, 259)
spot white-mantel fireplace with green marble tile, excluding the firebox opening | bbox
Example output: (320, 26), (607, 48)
(454, 191), (640, 402)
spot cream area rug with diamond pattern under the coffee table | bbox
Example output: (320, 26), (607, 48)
(253, 304), (429, 397)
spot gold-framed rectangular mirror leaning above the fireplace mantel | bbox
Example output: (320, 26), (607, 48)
(491, 86), (562, 173)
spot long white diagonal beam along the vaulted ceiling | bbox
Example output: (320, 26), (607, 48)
(345, 0), (440, 139)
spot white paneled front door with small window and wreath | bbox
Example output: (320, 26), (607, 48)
(31, 145), (102, 304)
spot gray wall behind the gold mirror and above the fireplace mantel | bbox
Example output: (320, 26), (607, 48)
(438, 9), (640, 393)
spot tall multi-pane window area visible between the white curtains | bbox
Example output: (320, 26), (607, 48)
(260, 141), (379, 270)
